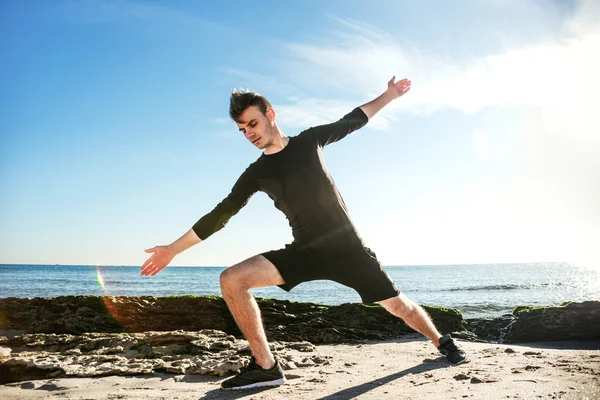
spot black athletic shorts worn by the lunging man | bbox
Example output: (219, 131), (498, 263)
(262, 244), (400, 303)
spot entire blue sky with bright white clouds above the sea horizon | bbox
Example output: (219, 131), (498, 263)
(0, 0), (600, 267)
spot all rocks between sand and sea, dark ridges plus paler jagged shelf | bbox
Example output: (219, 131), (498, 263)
(0, 296), (600, 384)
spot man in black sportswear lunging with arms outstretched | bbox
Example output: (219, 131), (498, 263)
(141, 77), (467, 389)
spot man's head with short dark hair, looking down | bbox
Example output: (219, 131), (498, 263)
(229, 90), (278, 149)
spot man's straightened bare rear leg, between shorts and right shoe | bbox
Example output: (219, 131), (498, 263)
(379, 293), (442, 348)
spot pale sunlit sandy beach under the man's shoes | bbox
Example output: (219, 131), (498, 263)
(0, 336), (600, 400)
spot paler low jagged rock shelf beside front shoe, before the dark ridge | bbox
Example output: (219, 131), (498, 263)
(0, 330), (328, 384)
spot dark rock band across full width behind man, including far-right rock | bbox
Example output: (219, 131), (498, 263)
(0, 296), (600, 344)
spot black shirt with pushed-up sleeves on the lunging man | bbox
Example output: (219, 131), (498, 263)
(192, 107), (368, 248)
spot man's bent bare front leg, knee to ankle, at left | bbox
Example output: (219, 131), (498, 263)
(221, 255), (285, 369)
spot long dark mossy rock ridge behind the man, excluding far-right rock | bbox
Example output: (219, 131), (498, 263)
(0, 296), (465, 344)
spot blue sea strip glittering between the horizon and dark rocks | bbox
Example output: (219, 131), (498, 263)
(0, 263), (600, 318)
